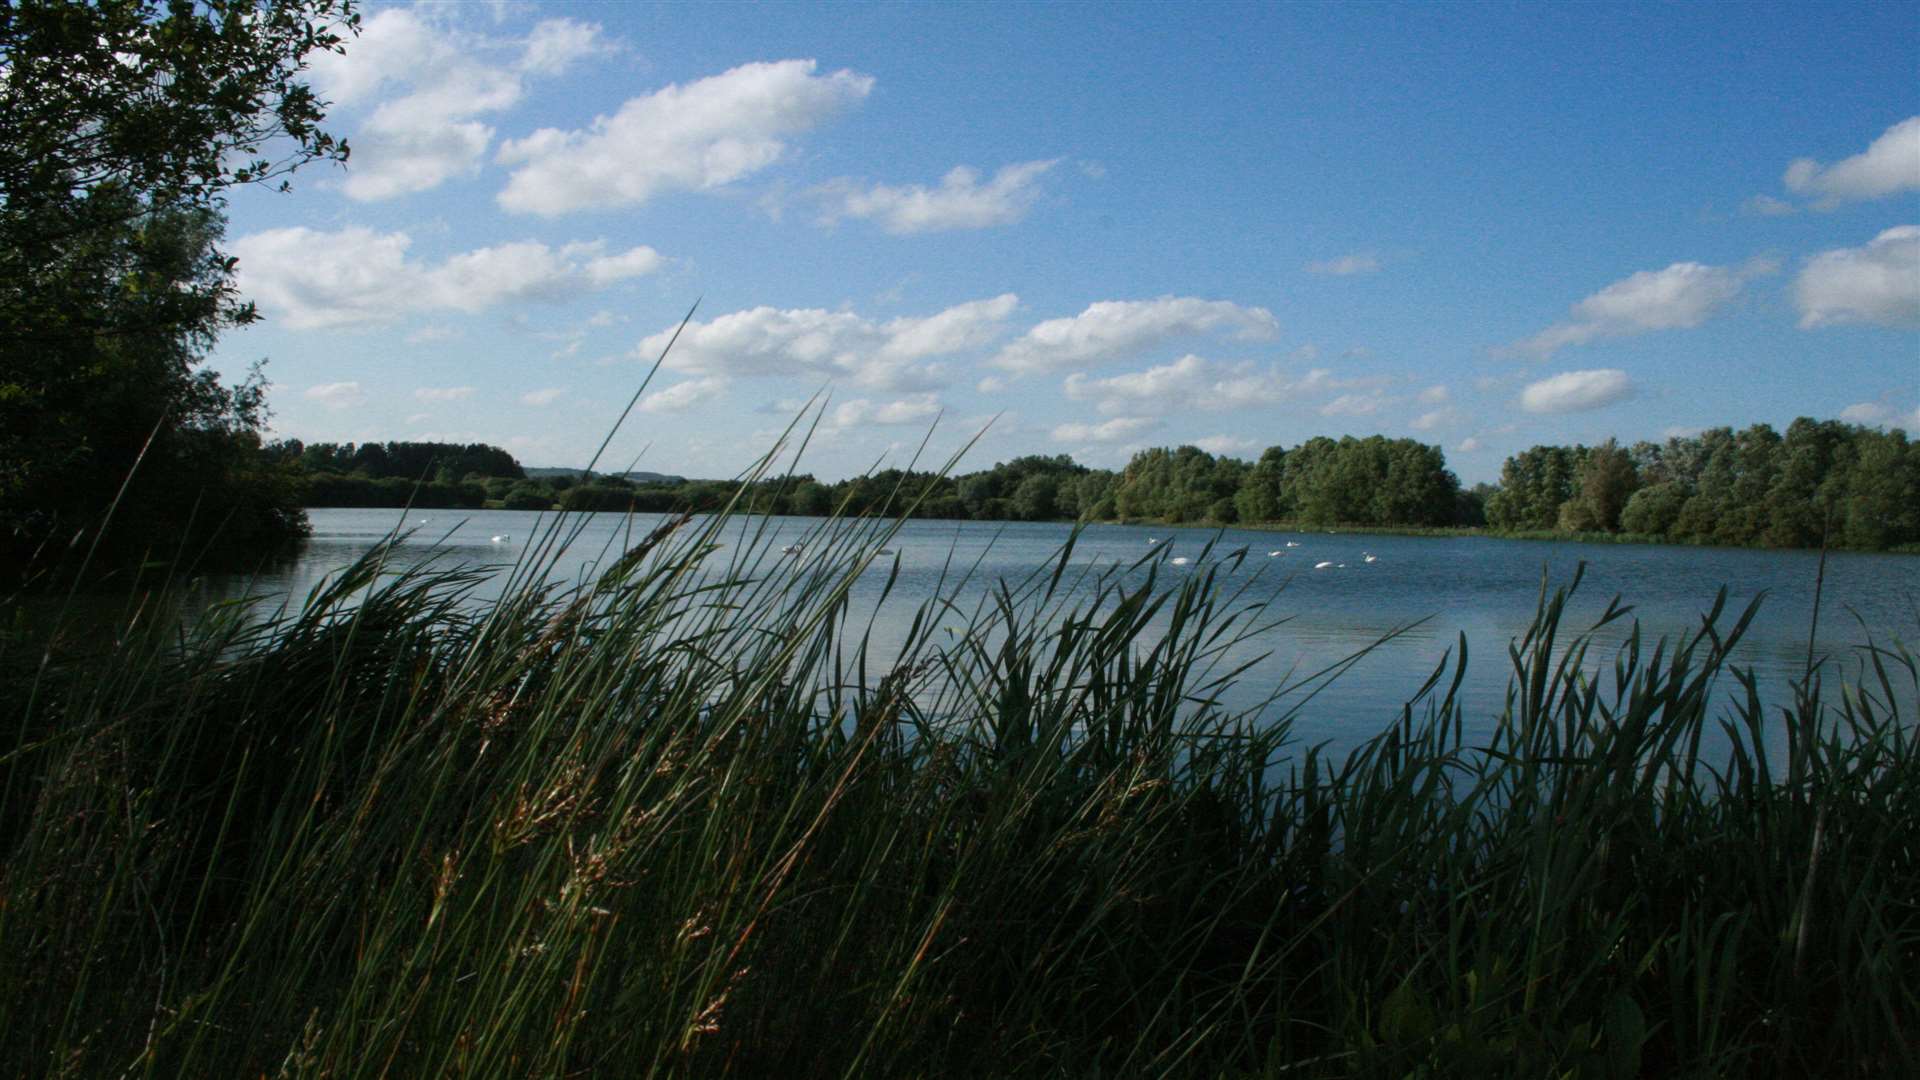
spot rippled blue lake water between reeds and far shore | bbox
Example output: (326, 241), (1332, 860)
(207, 509), (1920, 760)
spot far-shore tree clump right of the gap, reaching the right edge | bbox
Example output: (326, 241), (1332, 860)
(1486, 417), (1920, 550)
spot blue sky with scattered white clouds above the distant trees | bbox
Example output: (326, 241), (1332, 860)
(211, 2), (1920, 484)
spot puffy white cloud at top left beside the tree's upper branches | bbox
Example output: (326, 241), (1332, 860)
(311, 8), (605, 202)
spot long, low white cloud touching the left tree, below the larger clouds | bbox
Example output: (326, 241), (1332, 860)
(232, 227), (664, 331)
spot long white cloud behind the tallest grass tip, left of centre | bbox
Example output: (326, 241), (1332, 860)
(634, 292), (1020, 390)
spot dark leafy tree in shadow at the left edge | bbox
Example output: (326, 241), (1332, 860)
(0, 0), (357, 567)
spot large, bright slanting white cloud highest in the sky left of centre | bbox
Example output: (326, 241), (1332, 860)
(497, 60), (874, 217)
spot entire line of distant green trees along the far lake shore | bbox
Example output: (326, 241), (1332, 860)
(265, 419), (1920, 550)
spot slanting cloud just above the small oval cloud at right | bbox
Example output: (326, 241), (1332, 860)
(1513, 259), (1778, 359)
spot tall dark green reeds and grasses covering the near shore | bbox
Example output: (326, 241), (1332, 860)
(0, 491), (1920, 1078)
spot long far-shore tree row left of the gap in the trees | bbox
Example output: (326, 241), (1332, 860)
(263, 436), (1480, 527)
